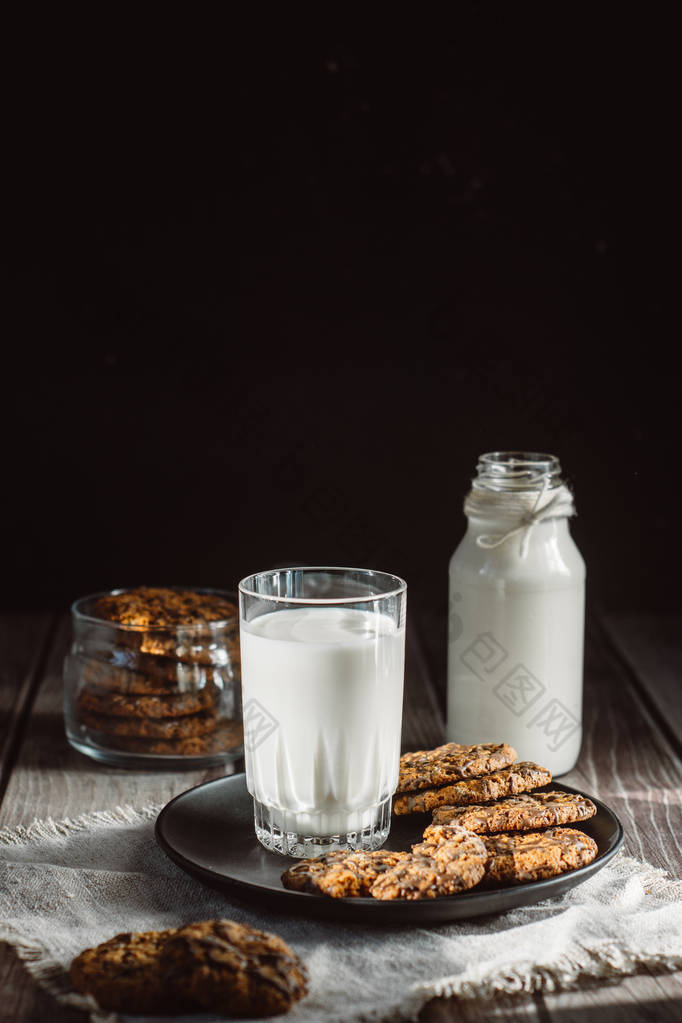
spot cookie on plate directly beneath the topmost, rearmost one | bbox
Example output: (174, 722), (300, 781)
(393, 760), (552, 814)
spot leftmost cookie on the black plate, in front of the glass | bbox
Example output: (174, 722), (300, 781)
(282, 849), (409, 898)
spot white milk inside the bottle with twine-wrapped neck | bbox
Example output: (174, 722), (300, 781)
(448, 482), (585, 774)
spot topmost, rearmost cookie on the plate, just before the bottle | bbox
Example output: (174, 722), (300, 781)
(398, 743), (516, 792)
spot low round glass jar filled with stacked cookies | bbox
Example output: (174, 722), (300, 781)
(63, 587), (243, 767)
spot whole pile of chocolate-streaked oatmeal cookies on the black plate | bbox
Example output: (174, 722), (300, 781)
(282, 743), (598, 899)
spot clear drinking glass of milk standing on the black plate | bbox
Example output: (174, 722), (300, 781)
(239, 568), (407, 856)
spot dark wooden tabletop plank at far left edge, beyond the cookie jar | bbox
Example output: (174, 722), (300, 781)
(0, 614), (53, 801)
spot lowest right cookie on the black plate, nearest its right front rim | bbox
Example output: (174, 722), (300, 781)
(482, 825), (598, 884)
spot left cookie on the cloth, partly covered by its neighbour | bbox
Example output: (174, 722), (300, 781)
(70, 931), (192, 1013)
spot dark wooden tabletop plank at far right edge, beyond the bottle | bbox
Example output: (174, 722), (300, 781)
(602, 612), (682, 756)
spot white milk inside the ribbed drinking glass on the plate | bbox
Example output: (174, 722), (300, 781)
(241, 607), (405, 836)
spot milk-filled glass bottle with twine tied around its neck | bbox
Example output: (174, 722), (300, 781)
(448, 451), (585, 774)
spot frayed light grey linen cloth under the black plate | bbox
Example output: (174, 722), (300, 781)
(0, 806), (682, 1023)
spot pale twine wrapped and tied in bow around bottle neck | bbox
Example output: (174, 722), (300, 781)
(464, 478), (576, 558)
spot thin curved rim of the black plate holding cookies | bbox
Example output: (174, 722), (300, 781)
(154, 771), (625, 925)
